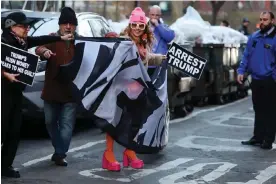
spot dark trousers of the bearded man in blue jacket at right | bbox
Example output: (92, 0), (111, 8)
(251, 78), (276, 143)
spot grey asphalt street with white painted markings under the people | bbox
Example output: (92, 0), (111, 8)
(1, 97), (276, 184)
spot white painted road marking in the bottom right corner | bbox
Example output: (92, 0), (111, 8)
(227, 165), (276, 184)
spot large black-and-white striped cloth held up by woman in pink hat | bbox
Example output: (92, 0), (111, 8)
(59, 37), (169, 153)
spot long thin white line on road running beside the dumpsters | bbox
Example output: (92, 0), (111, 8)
(170, 97), (249, 124)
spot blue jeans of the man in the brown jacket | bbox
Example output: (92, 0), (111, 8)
(44, 101), (77, 158)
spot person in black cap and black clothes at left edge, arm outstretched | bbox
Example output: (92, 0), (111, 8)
(1, 12), (73, 178)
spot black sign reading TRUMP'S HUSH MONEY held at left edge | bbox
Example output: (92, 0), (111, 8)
(1, 43), (38, 86)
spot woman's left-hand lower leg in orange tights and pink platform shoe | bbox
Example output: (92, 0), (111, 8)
(102, 134), (121, 171)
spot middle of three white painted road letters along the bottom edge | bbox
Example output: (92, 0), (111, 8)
(159, 162), (237, 184)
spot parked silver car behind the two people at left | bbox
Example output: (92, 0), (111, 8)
(1, 10), (113, 122)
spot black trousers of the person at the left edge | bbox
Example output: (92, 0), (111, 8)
(1, 85), (22, 169)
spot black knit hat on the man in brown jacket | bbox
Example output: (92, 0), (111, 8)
(58, 7), (78, 26)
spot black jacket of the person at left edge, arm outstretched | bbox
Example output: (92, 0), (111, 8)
(1, 31), (61, 93)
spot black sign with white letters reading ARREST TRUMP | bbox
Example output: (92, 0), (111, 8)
(167, 43), (207, 80)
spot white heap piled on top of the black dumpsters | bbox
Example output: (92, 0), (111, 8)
(170, 6), (248, 44)
